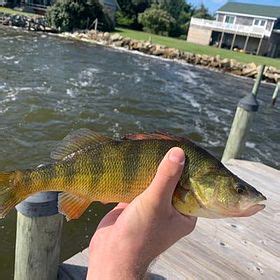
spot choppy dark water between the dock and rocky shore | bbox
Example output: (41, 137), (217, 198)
(0, 28), (280, 279)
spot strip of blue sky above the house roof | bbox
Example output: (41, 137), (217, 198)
(187, 0), (280, 12)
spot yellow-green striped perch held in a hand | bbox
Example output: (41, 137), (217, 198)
(0, 128), (266, 220)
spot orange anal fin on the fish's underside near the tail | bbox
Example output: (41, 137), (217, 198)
(58, 193), (91, 221)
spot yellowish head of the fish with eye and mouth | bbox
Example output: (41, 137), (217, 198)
(192, 170), (266, 218)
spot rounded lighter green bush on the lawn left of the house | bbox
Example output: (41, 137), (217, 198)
(139, 5), (175, 35)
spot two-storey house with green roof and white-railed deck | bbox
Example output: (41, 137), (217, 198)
(187, 2), (280, 57)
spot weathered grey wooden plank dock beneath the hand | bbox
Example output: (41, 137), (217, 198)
(59, 160), (280, 280)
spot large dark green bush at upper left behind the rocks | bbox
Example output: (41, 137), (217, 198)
(46, 0), (114, 31)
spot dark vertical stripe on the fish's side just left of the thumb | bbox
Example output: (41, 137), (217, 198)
(122, 141), (142, 192)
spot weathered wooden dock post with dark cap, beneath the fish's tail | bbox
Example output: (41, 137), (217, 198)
(14, 192), (63, 280)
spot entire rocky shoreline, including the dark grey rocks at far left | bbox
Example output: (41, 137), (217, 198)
(0, 13), (280, 84)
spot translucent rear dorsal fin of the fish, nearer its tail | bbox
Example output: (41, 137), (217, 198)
(51, 128), (112, 160)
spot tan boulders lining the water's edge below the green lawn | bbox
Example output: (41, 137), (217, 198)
(58, 31), (280, 84)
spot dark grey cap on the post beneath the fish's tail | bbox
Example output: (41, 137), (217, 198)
(16, 192), (58, 217)
